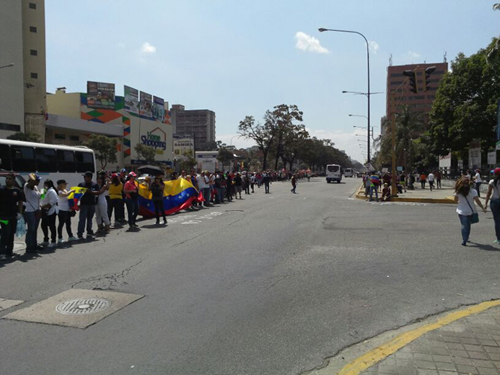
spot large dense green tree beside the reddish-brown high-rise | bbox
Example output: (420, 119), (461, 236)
(429, 38), (500, 159)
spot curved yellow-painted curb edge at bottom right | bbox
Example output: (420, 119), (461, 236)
(338, 300), (500, 375)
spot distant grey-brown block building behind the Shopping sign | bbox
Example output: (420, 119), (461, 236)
(170, 104), (216, 151)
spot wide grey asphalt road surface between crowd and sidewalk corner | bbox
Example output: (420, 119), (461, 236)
(0, 179), (500, 375)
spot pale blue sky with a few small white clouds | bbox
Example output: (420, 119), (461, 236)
(45, 0), (500, 161)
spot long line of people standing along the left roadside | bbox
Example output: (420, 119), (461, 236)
(0, 169), (304, 260)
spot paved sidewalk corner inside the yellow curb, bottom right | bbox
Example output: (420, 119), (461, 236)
(361, 307), (500, 375)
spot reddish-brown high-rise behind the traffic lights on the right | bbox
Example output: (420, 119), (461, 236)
(382, 62), (448, 134)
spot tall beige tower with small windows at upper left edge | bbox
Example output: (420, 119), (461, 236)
(0, 0), (46, 141)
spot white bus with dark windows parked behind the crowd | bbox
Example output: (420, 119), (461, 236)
(0, 139), (96, 187)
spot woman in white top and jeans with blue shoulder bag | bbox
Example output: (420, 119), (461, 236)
(454, 177), (486, 246)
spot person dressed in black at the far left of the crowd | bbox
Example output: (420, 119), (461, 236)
(0, 173), (23, 260)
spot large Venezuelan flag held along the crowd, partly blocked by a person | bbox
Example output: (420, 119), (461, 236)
(138, 178), (198, 217)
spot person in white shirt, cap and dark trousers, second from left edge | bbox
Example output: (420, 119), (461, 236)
(23, 173), (42, 254)
